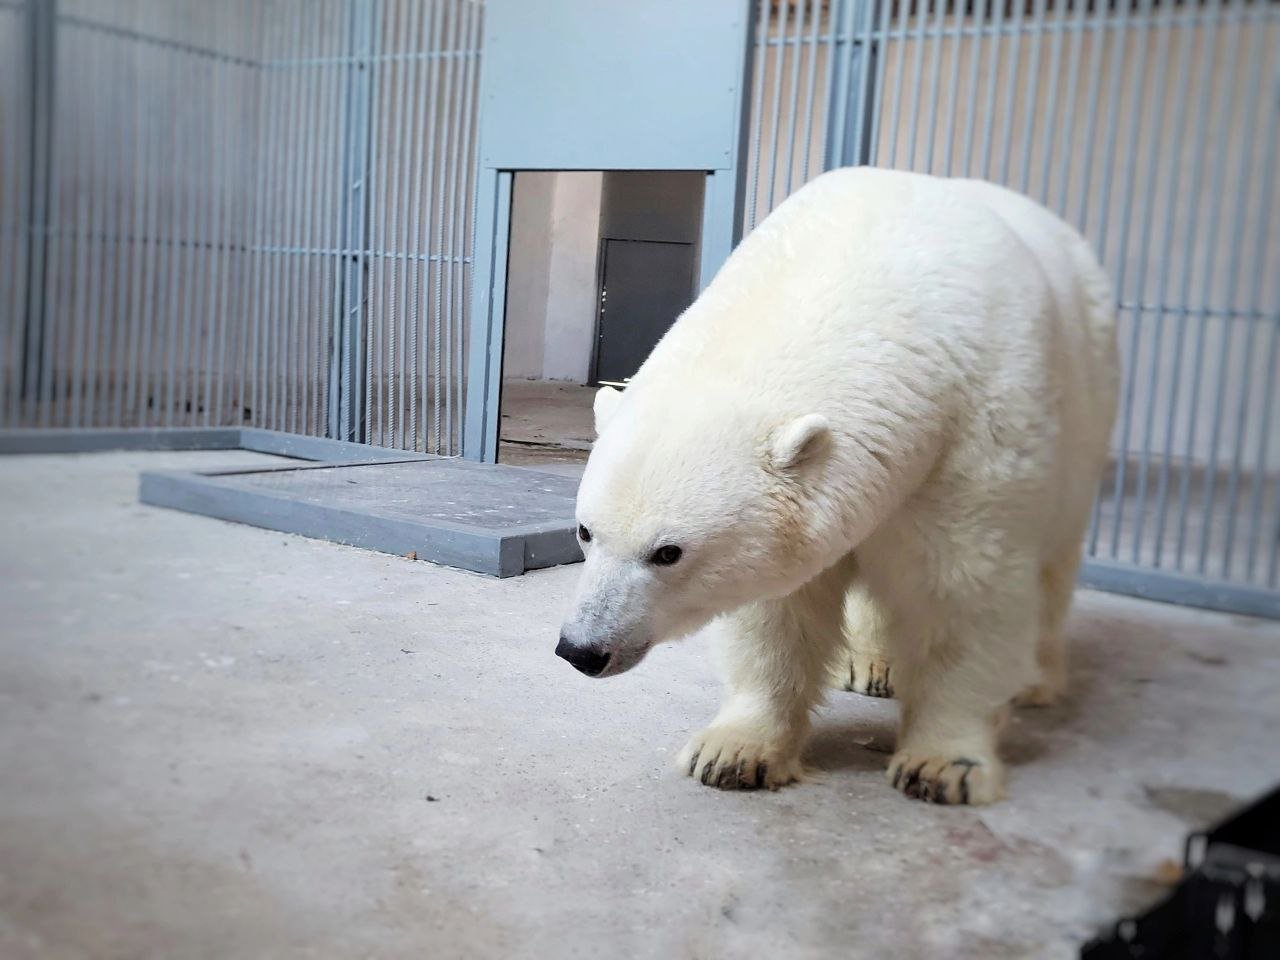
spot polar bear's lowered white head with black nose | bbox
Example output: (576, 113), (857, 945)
(556, 388), (838, 677)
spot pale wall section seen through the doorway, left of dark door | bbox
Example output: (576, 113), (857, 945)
(503, 172), (603, 383)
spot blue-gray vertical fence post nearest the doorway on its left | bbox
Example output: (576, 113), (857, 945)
(328, 0), (376, 443)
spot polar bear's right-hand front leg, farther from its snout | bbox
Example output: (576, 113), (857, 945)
(888, 568), (1039, 804)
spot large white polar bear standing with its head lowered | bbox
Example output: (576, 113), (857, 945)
(556, 168), (1119, 804)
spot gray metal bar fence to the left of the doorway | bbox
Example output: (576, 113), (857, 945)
(0, 0), (481, 453)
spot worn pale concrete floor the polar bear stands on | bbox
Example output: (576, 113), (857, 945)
(0, 453), (1280, 960)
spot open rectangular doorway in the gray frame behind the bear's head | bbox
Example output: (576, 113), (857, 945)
(498, 170), (707, 474)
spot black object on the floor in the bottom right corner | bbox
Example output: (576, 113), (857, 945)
(1080, 787), (1280, 960)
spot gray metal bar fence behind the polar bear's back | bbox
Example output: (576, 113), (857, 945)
(745, 0), (1280, 614)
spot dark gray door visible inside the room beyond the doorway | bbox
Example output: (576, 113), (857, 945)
(595, 239), (698, 383)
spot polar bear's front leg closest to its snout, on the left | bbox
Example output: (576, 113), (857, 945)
(677, 552), (850, 790)
